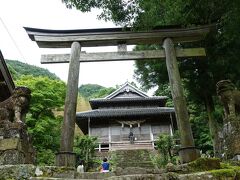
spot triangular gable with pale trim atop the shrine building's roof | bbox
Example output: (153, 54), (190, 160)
(105, 82), (148, 99)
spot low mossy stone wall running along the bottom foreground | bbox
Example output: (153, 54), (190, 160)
(0, 158), (240, 180)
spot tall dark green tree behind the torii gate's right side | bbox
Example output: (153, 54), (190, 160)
(61, 0), (240, 156)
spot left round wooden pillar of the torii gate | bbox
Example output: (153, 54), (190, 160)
(56, 42), (81, 167)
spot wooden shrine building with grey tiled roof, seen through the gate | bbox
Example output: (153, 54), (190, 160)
(76, 82), (177, 151)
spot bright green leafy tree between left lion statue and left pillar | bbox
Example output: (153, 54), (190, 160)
(16, 76), (66, 165)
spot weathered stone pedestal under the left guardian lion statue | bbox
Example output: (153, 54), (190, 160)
(0, 121), (35, 165)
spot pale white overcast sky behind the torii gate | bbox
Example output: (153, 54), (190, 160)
(0, 0), (136, 87)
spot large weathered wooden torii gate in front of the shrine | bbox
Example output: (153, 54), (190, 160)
(25, 25), (213, 166)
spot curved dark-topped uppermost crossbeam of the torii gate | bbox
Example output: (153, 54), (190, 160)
(24, 25), (214, 48)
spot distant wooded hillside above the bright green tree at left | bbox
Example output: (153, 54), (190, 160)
(6, 60), (59, 80)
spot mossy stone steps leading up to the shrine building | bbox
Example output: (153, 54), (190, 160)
(111, 149), (155, 169)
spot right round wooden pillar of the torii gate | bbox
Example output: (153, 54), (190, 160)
(163, 38), (199, 163)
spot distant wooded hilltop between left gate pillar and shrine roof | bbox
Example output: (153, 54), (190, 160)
(79, 84), (115, 99)
